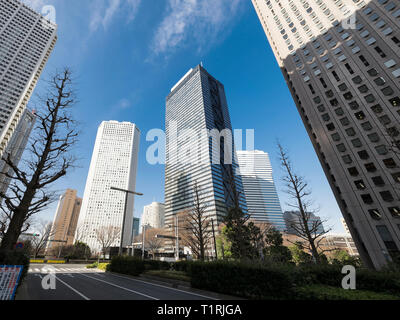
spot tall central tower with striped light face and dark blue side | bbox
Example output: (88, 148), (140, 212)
(165, 65), (247, 252)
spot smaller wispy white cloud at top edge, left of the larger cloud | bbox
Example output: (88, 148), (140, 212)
(89, 0), (141, 32)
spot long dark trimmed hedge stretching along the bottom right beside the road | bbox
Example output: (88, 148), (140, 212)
(190, 262), (400, 299)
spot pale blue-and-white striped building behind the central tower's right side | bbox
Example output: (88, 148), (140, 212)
(237, 150), (286, 231)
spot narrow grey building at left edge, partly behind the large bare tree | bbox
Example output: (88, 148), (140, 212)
(0, 109), (36, 196)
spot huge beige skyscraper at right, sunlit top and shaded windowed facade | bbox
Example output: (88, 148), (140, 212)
(253, 0), (400, 268)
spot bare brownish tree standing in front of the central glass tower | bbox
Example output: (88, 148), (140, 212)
(179, 182), (212, 261)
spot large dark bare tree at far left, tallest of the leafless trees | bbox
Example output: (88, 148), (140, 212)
(0, 68), (78, 250)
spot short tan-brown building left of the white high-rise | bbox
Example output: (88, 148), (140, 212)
(46, 189), (82, 251)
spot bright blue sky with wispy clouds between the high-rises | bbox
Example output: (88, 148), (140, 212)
(25, 0), (343, 232)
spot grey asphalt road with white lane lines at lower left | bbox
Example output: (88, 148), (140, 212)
(16, 264), (219, 300)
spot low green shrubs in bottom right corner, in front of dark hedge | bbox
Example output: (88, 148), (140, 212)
(295, 285), (399, 300)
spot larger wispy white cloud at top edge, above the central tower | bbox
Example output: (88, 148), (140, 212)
(152, 0), (243, 54)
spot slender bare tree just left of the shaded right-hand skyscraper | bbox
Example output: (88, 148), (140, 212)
(278, 143), (330, 263)
